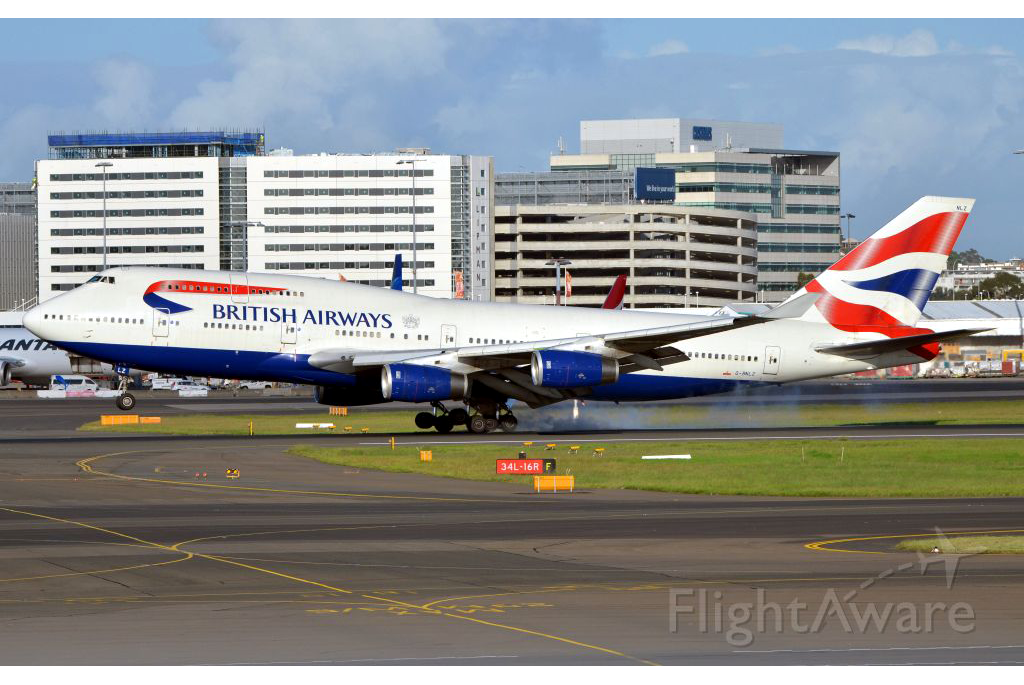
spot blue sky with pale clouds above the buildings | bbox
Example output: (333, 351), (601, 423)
(0, 19), (1024, 258)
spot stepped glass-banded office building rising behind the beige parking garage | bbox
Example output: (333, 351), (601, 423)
(496, 119), (842, 306)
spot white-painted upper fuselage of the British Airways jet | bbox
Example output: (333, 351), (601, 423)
(26, 267), (921, 397)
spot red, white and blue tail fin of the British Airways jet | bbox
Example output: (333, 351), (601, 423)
(791, 197), (974, 331)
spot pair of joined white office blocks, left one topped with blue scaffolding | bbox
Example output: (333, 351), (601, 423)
(37, 131), (494, 300)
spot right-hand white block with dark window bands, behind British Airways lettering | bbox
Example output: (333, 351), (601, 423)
(247, 154), (494, 301)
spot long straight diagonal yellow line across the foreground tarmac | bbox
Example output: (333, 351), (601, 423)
(0, 499), (656, 666)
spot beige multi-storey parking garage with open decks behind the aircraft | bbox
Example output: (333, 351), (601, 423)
(495, 205), (758, 308)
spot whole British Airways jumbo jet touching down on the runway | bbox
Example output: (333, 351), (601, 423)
(25, 197), (977, 433)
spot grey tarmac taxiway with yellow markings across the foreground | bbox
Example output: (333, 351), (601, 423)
(0, 436), (1024, 665)
